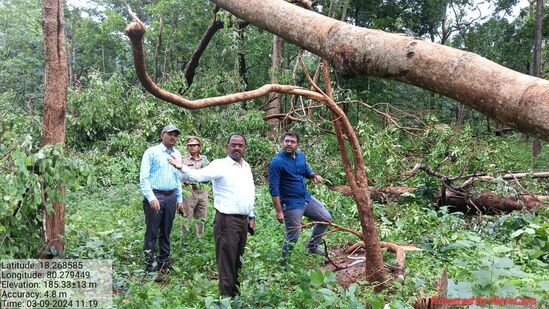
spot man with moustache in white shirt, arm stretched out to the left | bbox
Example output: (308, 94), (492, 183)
(168, 134), (255, 297)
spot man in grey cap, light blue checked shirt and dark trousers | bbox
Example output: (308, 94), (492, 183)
(139, 124), (183, 281)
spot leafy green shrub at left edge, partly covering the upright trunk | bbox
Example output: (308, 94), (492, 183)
(0, 96), (88, 258)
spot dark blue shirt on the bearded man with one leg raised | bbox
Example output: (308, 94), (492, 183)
(269, 150), (314, 209)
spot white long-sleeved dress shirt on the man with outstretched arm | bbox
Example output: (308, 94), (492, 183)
(180, 156), (255, 217)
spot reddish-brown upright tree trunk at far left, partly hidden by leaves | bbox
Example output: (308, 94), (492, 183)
(40, 0), (68, 257)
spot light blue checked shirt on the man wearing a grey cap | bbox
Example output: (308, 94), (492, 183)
(139, 143), (183, 203)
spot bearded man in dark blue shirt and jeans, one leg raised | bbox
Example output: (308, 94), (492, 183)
(269, 132), (332, 264)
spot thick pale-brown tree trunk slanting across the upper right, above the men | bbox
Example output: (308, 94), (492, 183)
(212, 0), (549, 140)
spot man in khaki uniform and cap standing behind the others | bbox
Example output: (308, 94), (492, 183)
(181, 136), (209, 238)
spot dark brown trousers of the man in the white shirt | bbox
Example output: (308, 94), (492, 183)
(214, 211), (248, 297)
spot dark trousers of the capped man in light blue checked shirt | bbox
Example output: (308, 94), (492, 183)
(143, 191), (177, 270)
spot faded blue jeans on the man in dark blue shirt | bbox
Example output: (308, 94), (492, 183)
(281, 196), (332, 259)
